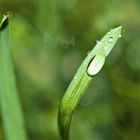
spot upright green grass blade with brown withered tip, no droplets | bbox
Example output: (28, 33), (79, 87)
(0, 14), (27, 140)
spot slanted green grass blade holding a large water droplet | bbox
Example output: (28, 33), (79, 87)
(58, 26), (122, 140)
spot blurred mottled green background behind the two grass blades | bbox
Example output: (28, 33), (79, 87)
(0, 0), (140, 140)
